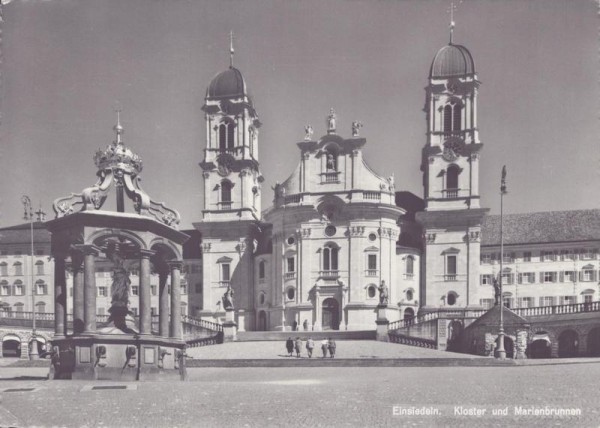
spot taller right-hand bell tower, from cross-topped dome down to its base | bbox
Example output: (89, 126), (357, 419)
(417, 18), (488, 312)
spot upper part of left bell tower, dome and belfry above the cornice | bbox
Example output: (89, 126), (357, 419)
(200, 36), (263, 221)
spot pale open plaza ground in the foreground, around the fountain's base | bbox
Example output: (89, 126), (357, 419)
(0, 360), (600, 427)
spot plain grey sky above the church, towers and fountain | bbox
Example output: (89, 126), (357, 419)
(0, 0), (600, 228)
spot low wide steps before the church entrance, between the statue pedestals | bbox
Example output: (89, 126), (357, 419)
(237, 330), (375, 342)
